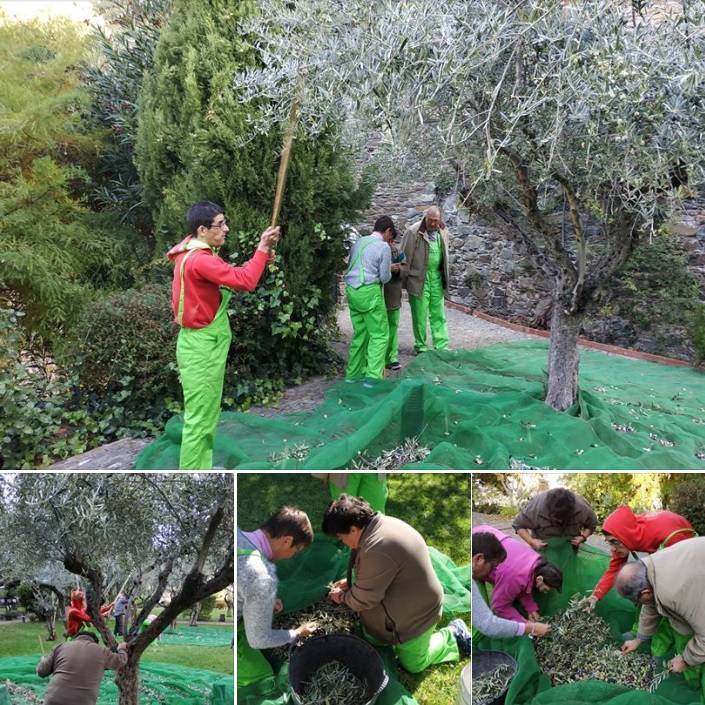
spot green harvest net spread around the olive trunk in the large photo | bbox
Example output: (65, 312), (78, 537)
(136, 341), (705, 470)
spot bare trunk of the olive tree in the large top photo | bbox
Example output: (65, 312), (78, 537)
(545, 301), (584, 411)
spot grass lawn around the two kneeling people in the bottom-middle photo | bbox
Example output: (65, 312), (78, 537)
(237, 473), (470, 705)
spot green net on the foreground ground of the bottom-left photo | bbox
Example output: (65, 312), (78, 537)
(0, 655), (234, 705)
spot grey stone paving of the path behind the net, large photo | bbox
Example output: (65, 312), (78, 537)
(48, 302), (532, 472)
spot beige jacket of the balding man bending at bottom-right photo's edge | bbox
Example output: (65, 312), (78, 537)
(639, 537), (705, 666)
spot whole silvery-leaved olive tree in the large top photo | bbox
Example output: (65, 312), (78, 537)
(234, 0), (705, 410)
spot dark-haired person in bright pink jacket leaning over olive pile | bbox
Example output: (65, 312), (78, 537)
(473, 525), (563, 622)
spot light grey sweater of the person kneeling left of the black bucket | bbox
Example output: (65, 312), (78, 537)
(237, 529), (290, 649)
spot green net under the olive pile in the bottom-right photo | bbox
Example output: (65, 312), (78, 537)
(473, 539), (705, 705)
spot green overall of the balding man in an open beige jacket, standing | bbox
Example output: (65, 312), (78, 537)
(409, 233), (448, 353)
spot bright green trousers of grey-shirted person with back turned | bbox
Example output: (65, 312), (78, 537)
(345, 284), (389, 379)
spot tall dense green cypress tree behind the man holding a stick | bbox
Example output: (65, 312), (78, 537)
(136, 0), (369, 398)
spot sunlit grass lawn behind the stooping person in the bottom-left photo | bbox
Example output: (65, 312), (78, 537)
(0, 623), (234, 674)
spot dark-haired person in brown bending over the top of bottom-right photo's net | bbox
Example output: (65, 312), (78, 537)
(512, 487), (597, 551)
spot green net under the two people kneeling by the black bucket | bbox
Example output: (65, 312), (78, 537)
(237, 534), (470, 705)
